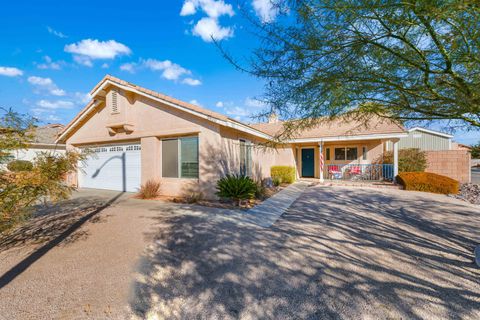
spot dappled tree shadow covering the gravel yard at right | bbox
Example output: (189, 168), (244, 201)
(131, 187), (480, 319)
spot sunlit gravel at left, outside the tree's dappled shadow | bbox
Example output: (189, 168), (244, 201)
(0, 191), (162, 320)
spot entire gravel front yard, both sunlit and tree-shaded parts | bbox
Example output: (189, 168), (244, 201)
(0, 187), (480, 319)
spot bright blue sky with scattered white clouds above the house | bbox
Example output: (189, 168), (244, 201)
(0, 0), (480, 143)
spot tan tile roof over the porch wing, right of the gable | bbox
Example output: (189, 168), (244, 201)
(250, 116), (405, 139)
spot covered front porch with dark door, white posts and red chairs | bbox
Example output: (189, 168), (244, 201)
(294, 137), (399, 182)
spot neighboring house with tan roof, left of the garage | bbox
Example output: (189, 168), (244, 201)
(4, 124), (66, 161)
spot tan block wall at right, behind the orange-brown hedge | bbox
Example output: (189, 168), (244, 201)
(425, 150), (471, 183)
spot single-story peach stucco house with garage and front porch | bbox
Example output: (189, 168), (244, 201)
(57, 75), (407, 198)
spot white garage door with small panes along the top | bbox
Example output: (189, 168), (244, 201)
(78, 144), (141, 192)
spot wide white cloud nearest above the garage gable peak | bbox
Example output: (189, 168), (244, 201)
(64, 39), (132, 67)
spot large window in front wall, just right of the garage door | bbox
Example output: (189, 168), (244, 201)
(162, 137), (198, 178)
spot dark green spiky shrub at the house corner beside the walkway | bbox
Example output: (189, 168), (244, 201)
(217, 175), (257, 205)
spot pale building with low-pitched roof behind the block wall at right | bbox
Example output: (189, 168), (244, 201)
(386, 127), (454, 151)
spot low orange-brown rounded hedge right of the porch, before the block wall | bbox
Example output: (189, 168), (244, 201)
(396, 172), (459, 194)
